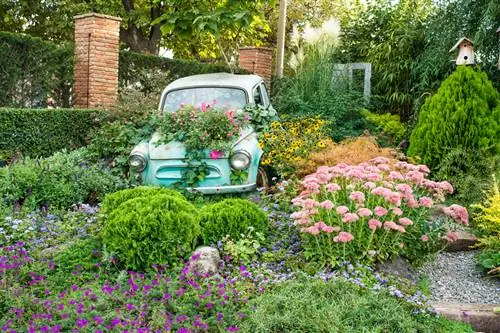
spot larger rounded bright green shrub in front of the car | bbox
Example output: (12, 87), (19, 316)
(102, 194), (200, 269)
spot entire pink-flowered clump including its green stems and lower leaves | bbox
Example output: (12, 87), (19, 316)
(292, 157), (468, 266)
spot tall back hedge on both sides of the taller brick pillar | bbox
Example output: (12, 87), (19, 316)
(0, 32), (247, 108)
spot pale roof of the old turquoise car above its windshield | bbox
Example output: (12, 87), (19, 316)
(164, 73), (262, 93)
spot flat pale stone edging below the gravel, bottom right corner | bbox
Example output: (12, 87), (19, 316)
(431, 303), (500, 333)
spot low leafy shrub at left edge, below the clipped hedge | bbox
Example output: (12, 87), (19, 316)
(0, 149), (122, 210)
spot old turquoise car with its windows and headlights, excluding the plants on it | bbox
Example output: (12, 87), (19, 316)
(129, 73), (274, 194)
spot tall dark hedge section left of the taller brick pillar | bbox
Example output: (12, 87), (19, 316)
(0, 32), (73, 107)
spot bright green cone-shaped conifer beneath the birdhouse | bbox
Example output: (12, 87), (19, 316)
(408, 66), (500, 168)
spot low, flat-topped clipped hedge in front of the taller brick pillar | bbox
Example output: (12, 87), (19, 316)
(0, 108), (104, 160)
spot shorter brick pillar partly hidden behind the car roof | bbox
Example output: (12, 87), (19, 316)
(239, 47), (273, 89)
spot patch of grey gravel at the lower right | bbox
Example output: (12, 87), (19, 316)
(420, 251), (500, 304)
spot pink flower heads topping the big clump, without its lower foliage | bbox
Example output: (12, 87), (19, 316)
(292, 157), (468, 253)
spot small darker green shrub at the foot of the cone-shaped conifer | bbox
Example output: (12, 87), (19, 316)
(435, 147), (500, 206)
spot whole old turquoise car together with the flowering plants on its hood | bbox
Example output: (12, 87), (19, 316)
(129, 73), (276, 193)
